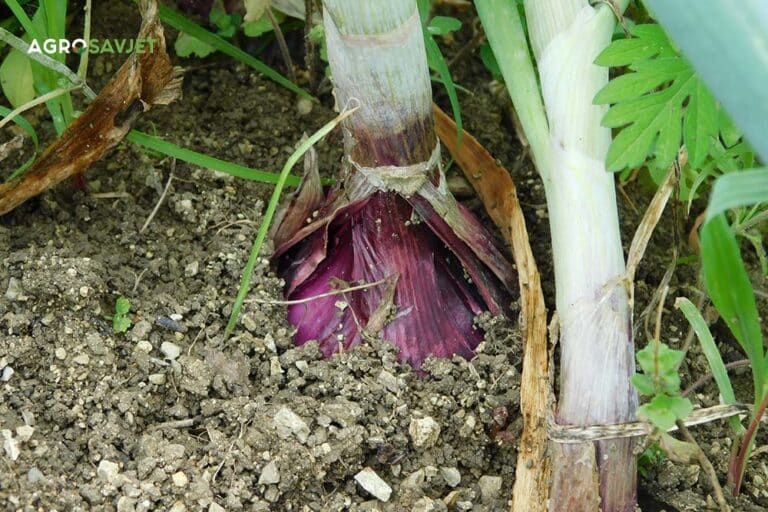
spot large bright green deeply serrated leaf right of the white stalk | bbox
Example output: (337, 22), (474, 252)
(594, 24), (720, 175)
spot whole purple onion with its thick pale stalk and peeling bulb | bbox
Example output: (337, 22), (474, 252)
(274, 0), (514, 367)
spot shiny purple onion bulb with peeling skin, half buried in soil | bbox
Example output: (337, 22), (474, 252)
(276, 190), (509, 368)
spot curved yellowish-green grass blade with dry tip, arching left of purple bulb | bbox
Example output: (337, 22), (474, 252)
(224, 107), (358, 337)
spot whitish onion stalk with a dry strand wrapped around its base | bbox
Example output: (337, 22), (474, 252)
(476, 0), (637, 512)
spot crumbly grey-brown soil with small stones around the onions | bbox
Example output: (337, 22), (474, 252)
(0, 2), (768, 512)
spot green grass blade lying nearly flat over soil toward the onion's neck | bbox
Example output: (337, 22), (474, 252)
(126, 130), (301, 187)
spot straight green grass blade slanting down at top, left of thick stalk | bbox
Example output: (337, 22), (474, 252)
(160, 4), (318, 102)
